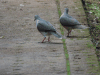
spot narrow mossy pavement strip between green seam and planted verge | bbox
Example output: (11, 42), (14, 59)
(60, 0), (100, 75)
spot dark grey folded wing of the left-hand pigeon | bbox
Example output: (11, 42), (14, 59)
(37, 21), (56, 32)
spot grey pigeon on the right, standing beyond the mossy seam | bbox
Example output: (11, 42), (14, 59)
(59, 8), (89, 36)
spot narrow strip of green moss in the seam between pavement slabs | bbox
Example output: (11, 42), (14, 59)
(56, 0), (71, 75)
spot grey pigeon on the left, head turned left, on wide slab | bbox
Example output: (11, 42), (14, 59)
(34, 15), (62, 43)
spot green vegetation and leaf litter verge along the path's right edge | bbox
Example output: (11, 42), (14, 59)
(85, 0), (100, 71)
